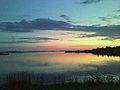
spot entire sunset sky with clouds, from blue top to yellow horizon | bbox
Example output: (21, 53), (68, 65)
(0, 0), (120, 50)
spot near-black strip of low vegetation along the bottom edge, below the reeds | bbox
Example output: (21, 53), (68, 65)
(0, 82), (120, 90)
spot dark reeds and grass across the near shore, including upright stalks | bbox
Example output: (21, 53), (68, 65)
(0, 72), (120, 90)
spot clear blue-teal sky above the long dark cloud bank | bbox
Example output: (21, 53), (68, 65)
(0, 0), (120, 25)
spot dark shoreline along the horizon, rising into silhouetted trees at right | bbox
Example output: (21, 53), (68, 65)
(0, 46), (120, 56)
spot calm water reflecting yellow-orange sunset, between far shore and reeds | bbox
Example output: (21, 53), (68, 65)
(0, 52), (120, 74)
